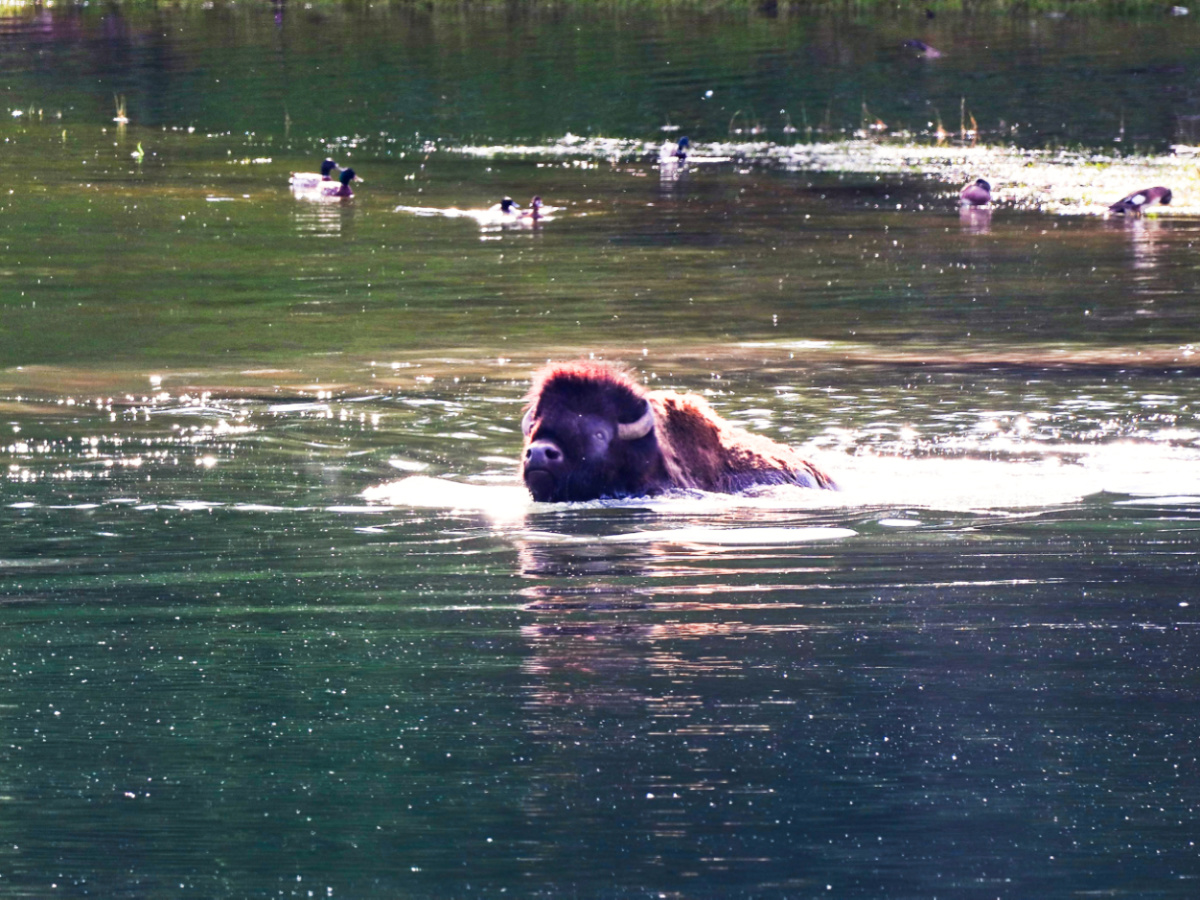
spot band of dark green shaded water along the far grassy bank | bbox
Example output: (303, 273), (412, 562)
(7, 2), (1200, 152)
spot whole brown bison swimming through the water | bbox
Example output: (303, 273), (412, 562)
(521, 361), (834, 503)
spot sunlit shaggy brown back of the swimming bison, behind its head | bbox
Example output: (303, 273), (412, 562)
(647, 391), (833, 492)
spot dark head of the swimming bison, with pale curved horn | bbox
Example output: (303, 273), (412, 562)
(521, 362), (662, 503)
